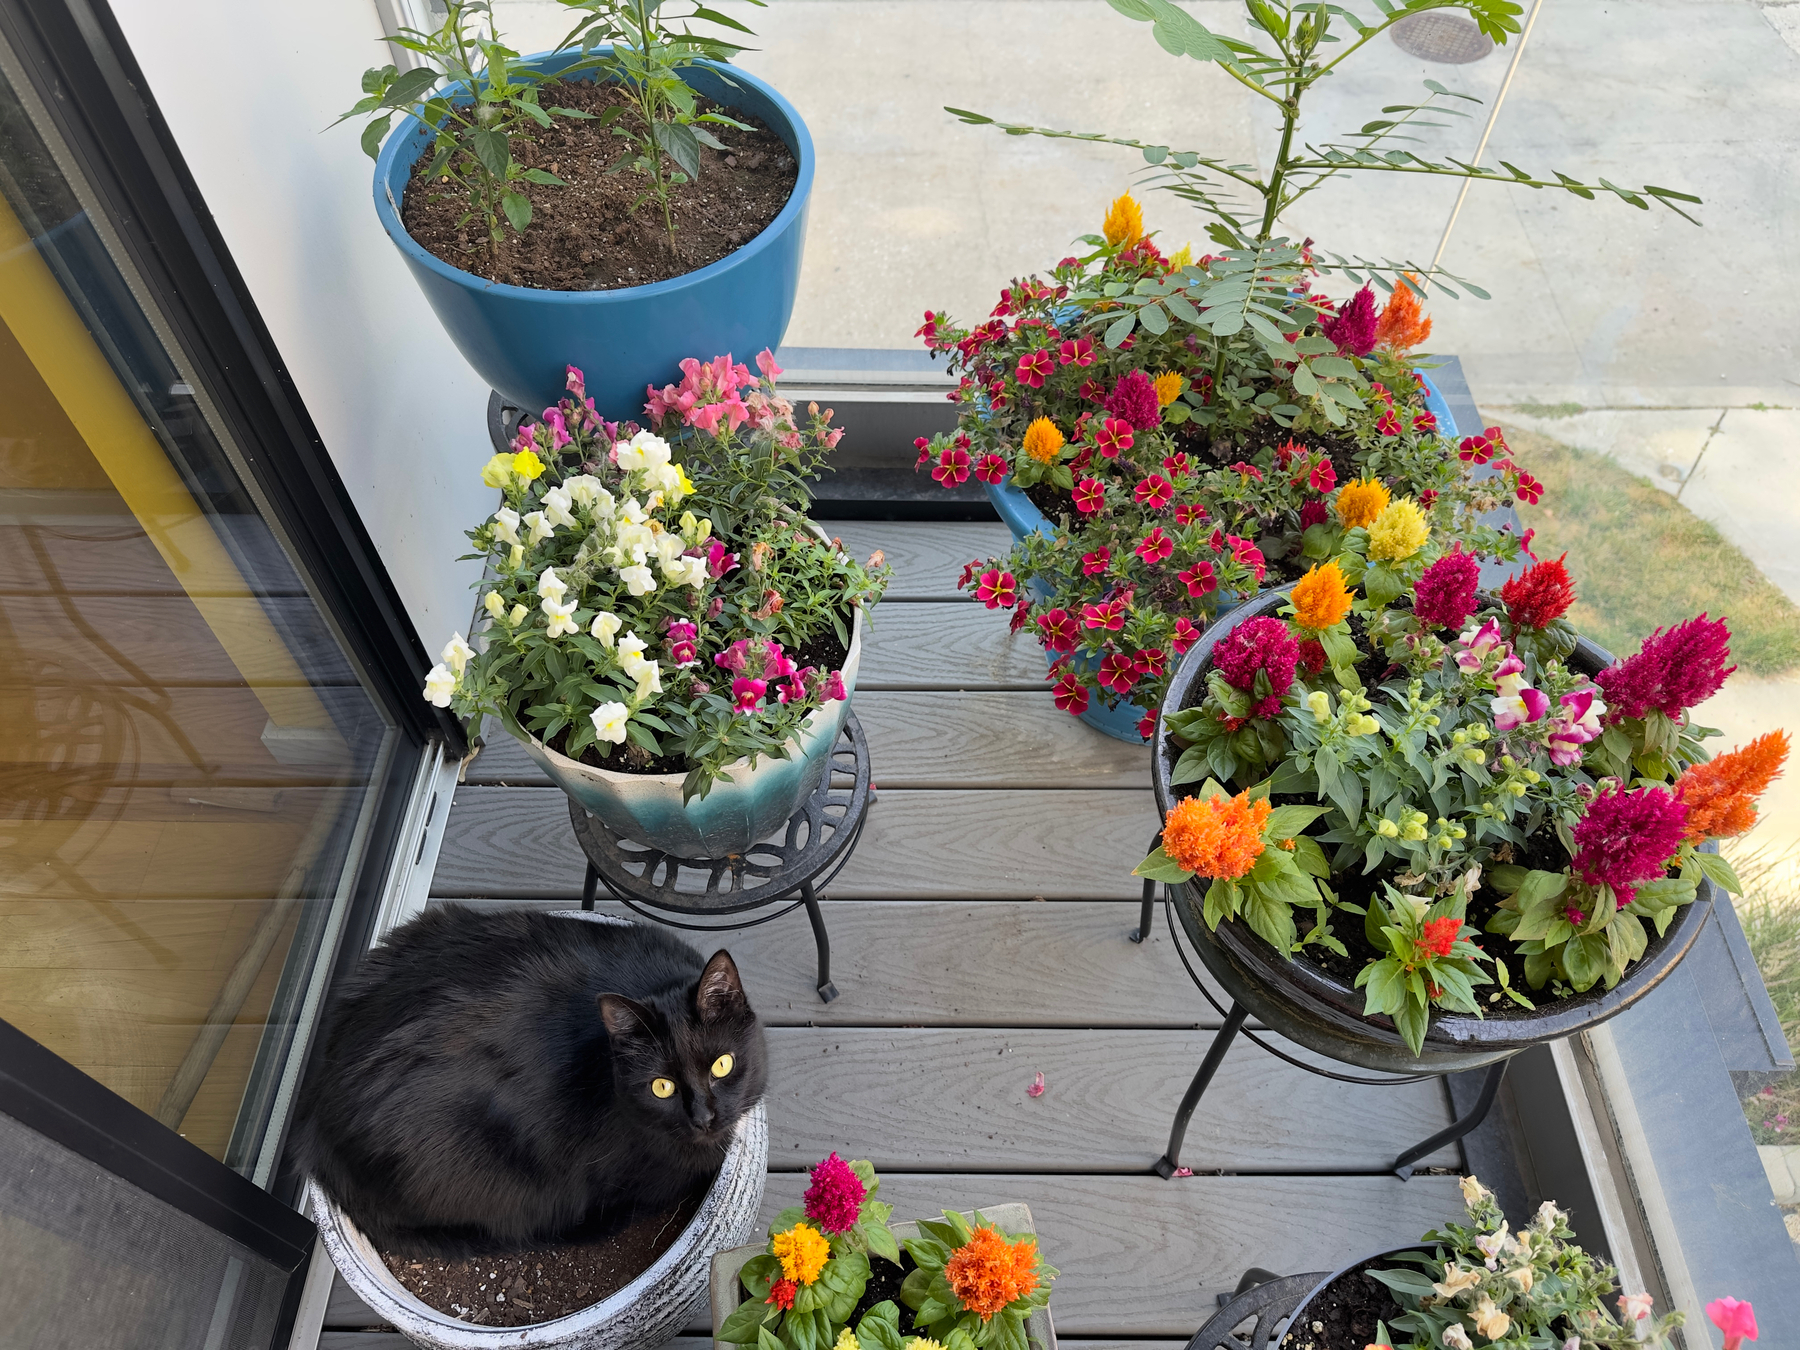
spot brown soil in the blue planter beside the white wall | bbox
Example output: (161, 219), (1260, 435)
(400, 81), (799, 290)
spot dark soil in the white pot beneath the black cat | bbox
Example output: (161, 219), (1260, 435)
(382, 1195), (702, 1327)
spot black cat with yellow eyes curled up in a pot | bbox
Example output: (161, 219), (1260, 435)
(295, 905), (767, 1256)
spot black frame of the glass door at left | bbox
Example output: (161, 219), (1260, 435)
(0, 0), (468, 1346)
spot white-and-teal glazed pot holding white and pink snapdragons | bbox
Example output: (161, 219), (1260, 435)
(508, 607), (862, 859)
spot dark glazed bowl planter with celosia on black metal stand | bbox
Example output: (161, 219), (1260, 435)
(1150, 589), (1717, 1073)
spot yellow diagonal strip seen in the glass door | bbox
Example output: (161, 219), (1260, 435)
(0, 198), (331, 729)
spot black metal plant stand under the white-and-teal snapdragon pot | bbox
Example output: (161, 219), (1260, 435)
(569, 711), (875, 1003)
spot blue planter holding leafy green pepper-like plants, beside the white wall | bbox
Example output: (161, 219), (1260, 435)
(374, 49), (814, 419)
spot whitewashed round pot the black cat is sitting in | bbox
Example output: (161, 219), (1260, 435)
(306, 911), (769, 1350)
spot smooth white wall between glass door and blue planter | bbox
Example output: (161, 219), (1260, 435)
(112, 0), (491, 666)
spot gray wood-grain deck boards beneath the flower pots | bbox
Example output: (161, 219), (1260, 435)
(320, 522), (1462, 1350)
